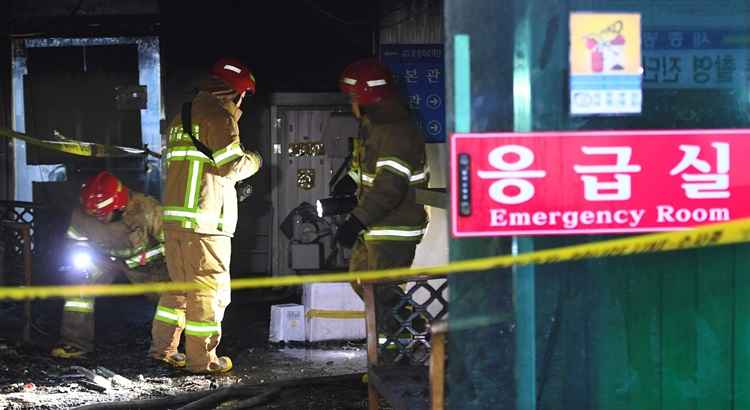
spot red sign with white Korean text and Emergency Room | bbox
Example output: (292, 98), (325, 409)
(451, 129), (750, 237)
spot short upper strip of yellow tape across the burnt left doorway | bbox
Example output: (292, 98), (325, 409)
(0, 128), (151, 158)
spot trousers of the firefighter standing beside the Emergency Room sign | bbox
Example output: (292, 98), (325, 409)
(349, 238), (417, 334)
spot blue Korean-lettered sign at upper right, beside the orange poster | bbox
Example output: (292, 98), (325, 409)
(643, 29), (750, 88)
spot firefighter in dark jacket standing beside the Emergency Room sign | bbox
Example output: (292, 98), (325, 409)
(336, 59), (429, 331)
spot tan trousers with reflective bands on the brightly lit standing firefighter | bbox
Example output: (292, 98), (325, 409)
(150, 230), (232, 373)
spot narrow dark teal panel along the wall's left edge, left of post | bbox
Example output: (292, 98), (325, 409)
(444, 0), (515, 409)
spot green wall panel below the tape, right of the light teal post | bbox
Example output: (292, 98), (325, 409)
(537, 242), (750, 410)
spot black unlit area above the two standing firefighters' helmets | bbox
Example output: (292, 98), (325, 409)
(160, 0), (374, 93)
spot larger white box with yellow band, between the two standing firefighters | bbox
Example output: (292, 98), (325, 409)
(302, 282), (367, 342)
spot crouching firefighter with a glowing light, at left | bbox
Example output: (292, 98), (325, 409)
(52, 171), (173, 365)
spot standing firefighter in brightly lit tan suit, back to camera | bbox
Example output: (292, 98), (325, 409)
(151, 59), (262, 373)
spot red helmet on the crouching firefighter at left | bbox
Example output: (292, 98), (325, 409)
(81, 171), (128, 217)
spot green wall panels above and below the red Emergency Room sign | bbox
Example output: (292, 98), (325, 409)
(445, 0), (750, 410)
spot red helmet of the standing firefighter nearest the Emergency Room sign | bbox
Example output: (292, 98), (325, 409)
(339, 58), (395, 105)
